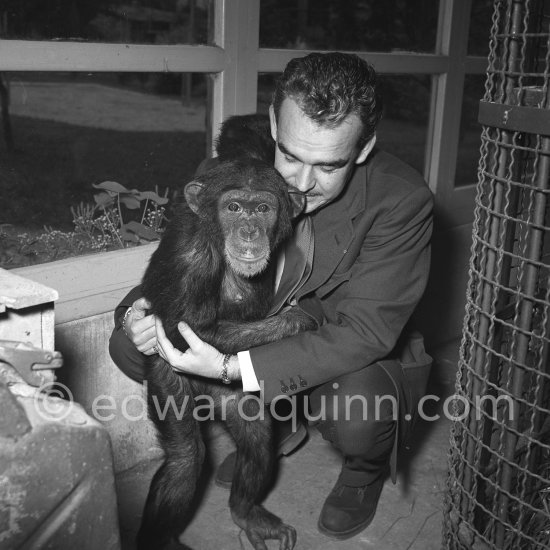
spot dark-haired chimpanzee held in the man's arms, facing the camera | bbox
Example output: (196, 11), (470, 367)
(138, 117), (317, 550)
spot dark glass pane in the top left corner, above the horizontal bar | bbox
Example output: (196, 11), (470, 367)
(0, 0), (210, 44)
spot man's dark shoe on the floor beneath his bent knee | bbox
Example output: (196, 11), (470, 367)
(317, 475), (385, 540)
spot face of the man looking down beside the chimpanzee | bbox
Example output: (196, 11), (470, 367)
(269, 98), (375, 214)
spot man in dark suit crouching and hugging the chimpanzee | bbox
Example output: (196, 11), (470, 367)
(110, 53), (432, 539)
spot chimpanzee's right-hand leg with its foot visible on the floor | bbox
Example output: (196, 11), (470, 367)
(219, 390), (296, 550)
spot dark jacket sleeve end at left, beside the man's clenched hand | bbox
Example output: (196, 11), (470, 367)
(109, 286), (146, 382)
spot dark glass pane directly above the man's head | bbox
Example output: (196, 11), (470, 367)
(260, 0), (439, 52)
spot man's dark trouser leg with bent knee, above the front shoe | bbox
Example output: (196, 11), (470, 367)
(308, 333), (432, 487)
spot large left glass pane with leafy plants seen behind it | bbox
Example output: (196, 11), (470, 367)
(0, 73), (207, 269)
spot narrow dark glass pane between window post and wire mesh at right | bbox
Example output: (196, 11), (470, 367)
(455, 75), (485, 187)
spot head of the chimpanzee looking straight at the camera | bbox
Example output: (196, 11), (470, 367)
(184, 159), (305, 277)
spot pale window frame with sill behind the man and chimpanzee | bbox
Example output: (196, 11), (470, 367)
(5, 0), (487, 324)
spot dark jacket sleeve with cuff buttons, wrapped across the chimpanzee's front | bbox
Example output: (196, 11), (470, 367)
(250, 186), (432, 402)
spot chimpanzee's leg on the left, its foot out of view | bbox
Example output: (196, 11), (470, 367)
(137, 358), (204, 550)
